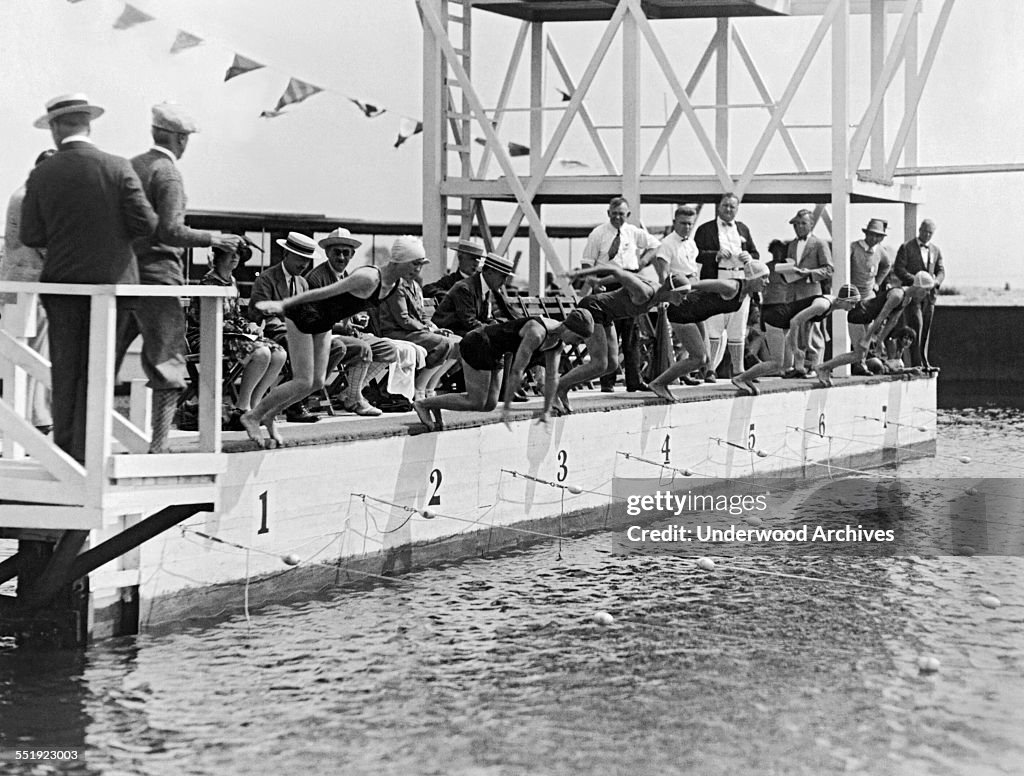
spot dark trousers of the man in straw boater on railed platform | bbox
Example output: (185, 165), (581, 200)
(40, 294), (131, 464)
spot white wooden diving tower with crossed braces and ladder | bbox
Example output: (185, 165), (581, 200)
(417, 0), (954, 313)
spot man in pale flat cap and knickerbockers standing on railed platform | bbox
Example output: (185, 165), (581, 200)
(117, 102), (242, 452)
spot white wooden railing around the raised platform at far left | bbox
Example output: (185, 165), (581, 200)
(0, 281), (237, 507)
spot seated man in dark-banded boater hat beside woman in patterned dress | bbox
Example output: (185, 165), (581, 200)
(246, 231), (325, 423)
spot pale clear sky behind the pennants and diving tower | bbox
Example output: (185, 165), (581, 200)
(0, 0), (1024, 287)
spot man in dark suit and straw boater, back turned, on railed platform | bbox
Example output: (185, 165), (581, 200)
(22, 94), (157, 463)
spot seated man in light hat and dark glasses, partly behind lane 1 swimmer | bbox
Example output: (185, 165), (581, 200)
(306, 226), (398, 416)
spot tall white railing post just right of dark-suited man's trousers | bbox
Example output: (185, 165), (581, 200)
(85, 295), (117, 507)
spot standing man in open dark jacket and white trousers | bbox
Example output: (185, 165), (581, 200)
(693, 192), (760, 383)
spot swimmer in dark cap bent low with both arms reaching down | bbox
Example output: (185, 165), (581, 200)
(413, 309), (594, 431)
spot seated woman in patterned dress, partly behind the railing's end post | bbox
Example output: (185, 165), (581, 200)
(188, 244), (288, 431)
